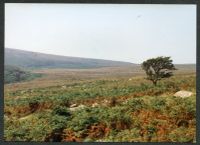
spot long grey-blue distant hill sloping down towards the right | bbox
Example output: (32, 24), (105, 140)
(5, 48), (134, 69)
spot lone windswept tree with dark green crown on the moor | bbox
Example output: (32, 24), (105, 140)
(142, 56), (176, 86)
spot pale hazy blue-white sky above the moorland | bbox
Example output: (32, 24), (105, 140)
(5, 3), (196, 64)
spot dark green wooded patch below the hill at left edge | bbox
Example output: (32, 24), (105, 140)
(4, 65), (42, 84)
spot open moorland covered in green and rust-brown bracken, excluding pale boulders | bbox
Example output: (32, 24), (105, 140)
(4, 68), (196, 142)
